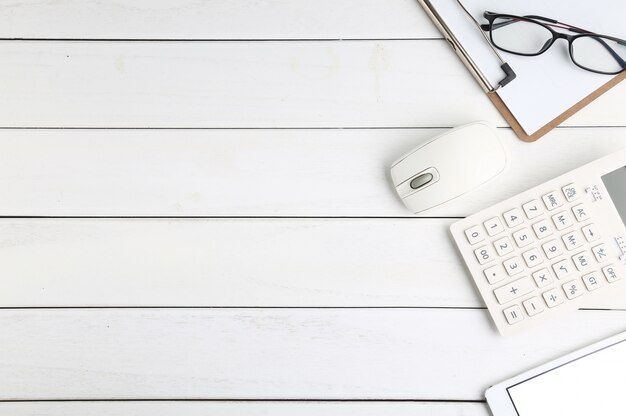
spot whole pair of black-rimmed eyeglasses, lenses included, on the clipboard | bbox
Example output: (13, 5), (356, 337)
(480, 12), (626, 75)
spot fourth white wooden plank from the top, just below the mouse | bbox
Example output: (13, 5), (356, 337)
(0, 219), (626, 308)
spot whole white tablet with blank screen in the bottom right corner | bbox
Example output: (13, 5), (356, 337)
(485, 332), (626, 416)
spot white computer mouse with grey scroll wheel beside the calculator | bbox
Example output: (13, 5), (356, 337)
(391, 121), (507, 213)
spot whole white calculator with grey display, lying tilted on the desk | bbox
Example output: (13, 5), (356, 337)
(451, 149), (626, 335)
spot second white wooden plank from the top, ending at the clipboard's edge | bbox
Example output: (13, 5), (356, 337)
(0, 40), (502, 128)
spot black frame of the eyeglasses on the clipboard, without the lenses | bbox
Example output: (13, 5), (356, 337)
(480, 11), (626, 75)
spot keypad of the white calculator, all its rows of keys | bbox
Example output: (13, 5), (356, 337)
(458, 183), (622, 332)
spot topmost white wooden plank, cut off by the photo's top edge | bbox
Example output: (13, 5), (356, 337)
(0, 0), (440, 39)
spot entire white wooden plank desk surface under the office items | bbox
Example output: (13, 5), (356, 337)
(0, 0), (626, 416)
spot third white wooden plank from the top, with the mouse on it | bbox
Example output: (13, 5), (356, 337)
(0, 128), (626, 217)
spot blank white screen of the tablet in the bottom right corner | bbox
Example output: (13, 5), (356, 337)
(507, 340), (626, 416)
